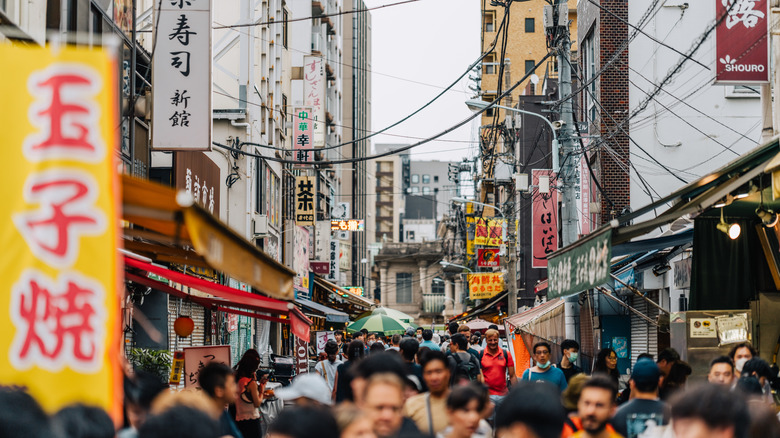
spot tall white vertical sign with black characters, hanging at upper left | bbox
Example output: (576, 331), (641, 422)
(152, 1), (211, 151)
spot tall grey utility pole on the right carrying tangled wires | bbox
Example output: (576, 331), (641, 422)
(552, 0), (579, 339)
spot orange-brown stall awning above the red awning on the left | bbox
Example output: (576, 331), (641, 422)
(122, 175), (295, 300)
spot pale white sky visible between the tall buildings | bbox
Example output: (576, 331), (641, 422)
(365, 0), (480, 161)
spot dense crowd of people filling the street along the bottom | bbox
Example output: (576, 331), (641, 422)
(0, 324), (780, 438)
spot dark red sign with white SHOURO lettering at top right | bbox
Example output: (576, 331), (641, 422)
(710, 0), (769, 85)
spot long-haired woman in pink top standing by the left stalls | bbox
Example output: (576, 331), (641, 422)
(235, 348), (263, 438)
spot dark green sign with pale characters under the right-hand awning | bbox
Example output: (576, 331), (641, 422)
(547, 229), (612, 300)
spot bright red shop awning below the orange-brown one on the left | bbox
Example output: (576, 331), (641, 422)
(125, 257), (312, 339)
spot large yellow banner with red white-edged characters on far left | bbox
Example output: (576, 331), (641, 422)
(0, 44), (124, 419)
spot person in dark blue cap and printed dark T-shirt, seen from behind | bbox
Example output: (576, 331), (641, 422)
(612, 359), (669, 438)
